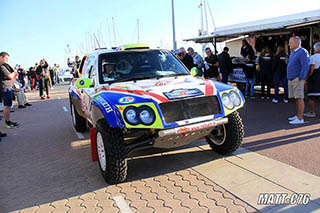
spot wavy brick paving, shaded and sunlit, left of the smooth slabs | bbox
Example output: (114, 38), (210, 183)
(0, 84), (256, 213)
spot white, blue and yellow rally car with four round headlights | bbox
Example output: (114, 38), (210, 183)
(69, 44), (245, 184)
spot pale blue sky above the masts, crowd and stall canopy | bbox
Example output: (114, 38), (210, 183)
(0, 0), (320, 67)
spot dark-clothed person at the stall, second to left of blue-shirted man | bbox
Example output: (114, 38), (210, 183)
(259, 47), (272, 99)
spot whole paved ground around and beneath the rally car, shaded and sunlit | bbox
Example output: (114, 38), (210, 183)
(0, 83), (320, 212)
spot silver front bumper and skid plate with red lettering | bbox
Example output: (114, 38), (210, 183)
(153, 118), (228, 148)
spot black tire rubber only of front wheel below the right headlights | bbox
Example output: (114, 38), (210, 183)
(206, 111), (244, 155)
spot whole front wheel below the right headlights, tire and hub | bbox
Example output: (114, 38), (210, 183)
(206, 111), (244, 155)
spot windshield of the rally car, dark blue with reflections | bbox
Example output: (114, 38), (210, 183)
(99, 50), (190, 84)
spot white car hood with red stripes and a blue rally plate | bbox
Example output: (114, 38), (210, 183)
(102, 76), (217, 103)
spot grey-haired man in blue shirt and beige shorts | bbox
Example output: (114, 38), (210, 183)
(287, 36), (309, 124)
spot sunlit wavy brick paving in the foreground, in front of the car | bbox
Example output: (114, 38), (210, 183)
(8, 169), (256, 213)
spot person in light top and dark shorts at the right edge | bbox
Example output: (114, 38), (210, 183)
(303, 42), (320, 118)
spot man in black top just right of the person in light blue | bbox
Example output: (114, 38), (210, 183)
(204, 47), (219, 81)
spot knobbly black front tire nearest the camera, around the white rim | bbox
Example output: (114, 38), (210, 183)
(95, 120), (127, 184)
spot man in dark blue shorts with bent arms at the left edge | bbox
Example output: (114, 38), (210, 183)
(0, 52), (19, 129)
